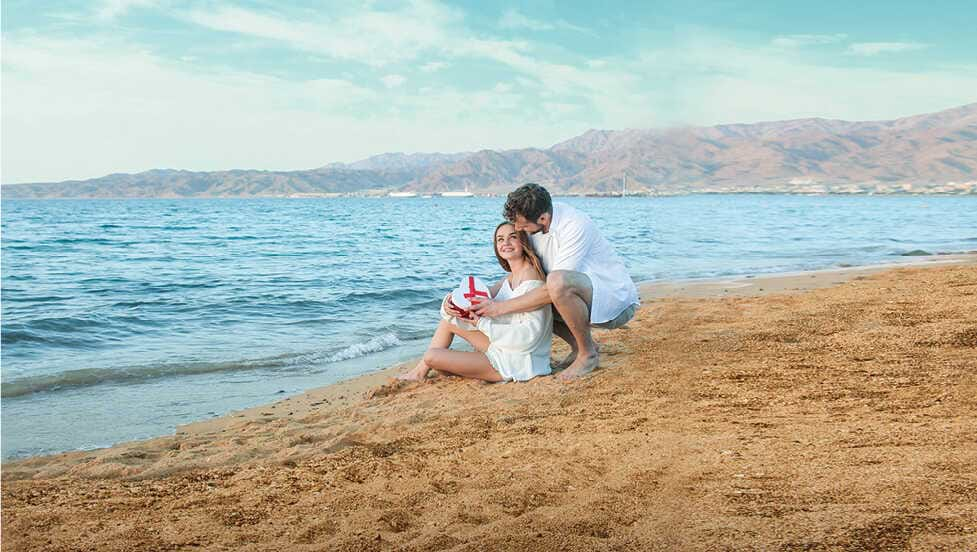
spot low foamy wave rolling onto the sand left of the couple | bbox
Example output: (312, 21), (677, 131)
(0, 333), (403, 398)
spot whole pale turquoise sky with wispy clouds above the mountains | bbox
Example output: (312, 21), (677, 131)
(0, 0), (977, 184)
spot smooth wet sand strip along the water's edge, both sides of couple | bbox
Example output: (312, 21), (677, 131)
(0, 253), (977, 479)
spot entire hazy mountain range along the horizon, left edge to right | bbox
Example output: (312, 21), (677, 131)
(2, 103), (977, 198)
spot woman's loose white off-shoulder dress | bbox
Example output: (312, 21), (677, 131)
(441, 278), (553, 381)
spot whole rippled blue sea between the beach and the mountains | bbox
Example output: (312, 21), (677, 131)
(0, 195), (977, 458)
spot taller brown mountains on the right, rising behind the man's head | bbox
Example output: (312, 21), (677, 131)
(407, 103), (977, 193)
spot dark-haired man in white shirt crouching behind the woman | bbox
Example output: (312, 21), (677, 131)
(472, 184), (638, 380)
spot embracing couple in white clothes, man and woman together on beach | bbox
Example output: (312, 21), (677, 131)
(400, 184), (638, 382)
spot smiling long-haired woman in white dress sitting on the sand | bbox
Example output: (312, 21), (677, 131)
(400, 222), (553, 382)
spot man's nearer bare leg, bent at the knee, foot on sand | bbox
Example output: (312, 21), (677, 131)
(546, 270), (600, 380)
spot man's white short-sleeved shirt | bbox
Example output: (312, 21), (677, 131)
(530, 203), (638, 324)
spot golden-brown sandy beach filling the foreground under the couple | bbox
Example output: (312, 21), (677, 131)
(2, 257), (977, 550)
